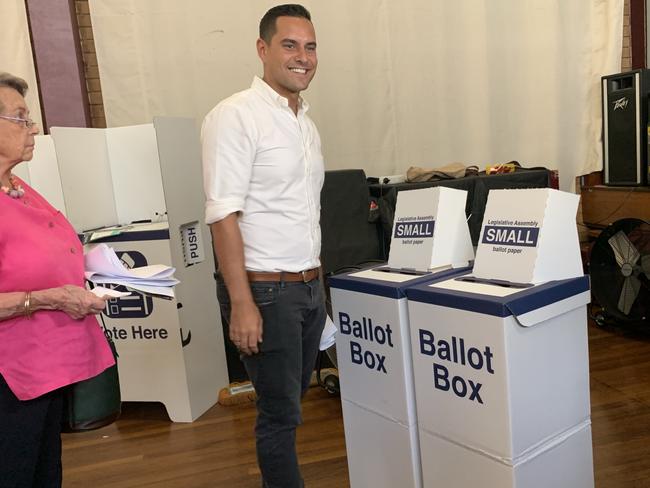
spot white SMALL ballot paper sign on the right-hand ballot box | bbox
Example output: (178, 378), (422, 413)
(473, 188), (583, 283)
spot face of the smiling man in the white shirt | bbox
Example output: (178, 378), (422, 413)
(257, 17), (318, 99)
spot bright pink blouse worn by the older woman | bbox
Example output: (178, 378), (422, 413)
(0, 181), (115, 400)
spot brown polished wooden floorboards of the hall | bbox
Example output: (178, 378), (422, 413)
(63, 318), (650, 488)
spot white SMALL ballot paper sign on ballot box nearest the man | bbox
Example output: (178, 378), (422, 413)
(388, 187), (474, 271)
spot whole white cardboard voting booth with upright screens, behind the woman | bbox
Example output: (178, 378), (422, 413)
(29, 117), (228, 422)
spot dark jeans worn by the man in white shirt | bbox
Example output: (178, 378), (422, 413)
(217, 279), (326, 488)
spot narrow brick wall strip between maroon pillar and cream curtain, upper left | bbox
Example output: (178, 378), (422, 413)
(75, 0), (106, 128)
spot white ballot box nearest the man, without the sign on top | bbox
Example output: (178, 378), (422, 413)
(330, 267), (467, 488)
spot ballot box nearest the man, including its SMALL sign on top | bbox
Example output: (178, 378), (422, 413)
(329, 188), (473, 488)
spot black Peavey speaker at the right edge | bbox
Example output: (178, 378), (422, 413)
(602, 69), (650, 186)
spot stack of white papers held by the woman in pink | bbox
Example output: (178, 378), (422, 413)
(85, 244), (179, 298)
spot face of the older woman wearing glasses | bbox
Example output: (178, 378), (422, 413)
(0, 86), (38, 165)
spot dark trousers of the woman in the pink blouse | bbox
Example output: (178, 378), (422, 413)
(0, 376), (63, 488)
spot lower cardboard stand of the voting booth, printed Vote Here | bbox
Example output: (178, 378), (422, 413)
(86, 222), (227, 422)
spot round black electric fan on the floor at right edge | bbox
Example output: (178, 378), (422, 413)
(589, 218), (650, 323)
